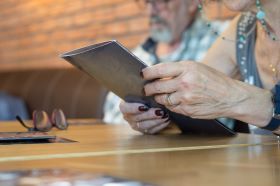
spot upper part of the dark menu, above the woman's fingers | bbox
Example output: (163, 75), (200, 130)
(60, 41), (161, 107)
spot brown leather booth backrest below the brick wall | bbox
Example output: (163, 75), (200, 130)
(0, 68), (106, 118)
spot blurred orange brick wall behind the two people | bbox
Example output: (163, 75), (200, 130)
(0, 0), (233, 71)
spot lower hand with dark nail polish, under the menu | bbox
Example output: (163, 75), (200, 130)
(120, 102), (170, 134)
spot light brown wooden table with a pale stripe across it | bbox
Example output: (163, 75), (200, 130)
(0, 120), (280, 186)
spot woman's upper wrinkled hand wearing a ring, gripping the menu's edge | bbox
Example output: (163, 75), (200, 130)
(142, 61), (246, 119)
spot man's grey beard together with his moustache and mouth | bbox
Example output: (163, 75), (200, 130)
(150, 16), (173, 43)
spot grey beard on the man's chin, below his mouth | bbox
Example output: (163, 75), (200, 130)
(150, 28), (173, 43)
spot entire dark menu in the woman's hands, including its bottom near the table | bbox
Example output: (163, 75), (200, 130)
(60, 41), (235, 136)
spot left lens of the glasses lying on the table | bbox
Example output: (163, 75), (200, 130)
(33, 110), (52, 131)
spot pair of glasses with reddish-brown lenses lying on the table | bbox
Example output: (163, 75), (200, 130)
(16, 109), (68, 132)
